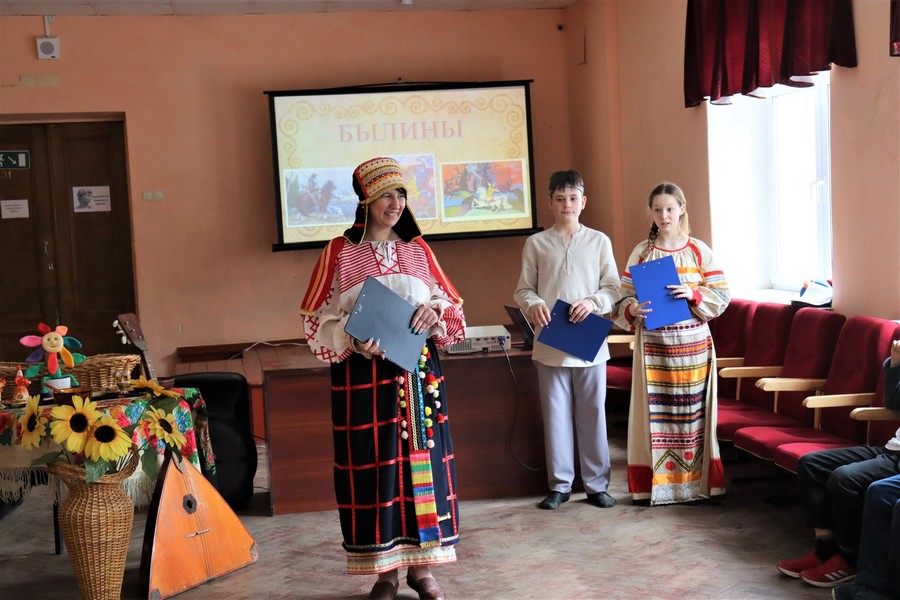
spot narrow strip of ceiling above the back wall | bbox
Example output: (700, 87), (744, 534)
(0, 0), (577, 16)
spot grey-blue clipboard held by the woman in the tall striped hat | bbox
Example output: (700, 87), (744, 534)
(344, 276), (426, 371)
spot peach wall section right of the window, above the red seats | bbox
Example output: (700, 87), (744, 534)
(831, 0), (900, 319)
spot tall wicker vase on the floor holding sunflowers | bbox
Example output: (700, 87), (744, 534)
(48, 447), (139, 600)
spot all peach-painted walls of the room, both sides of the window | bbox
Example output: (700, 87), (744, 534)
(0, 0), (900, 372)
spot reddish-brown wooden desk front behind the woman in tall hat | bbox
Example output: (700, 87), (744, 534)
(263, 350), (547, 514)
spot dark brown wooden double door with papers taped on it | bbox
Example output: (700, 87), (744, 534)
(0, 122), (135, 362)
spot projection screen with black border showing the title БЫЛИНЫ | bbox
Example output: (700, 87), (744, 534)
(265, 81), (537, 251)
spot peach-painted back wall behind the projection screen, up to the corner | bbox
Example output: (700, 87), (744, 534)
(0, 10), (570, 373)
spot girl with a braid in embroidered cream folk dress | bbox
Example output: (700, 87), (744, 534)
(613, 183), (730, 505)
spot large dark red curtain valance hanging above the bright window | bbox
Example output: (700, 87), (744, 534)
(684, 0), (856, 107)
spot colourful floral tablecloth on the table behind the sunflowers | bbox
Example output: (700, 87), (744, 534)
(0, 388), (215, 507)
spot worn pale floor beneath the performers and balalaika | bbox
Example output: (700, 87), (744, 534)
(0, 412), (830, 600)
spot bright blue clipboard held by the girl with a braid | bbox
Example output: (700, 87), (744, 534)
(628, 256), (691, 329)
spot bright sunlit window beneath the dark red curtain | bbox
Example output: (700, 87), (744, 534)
(707, 72), (831, 292)
